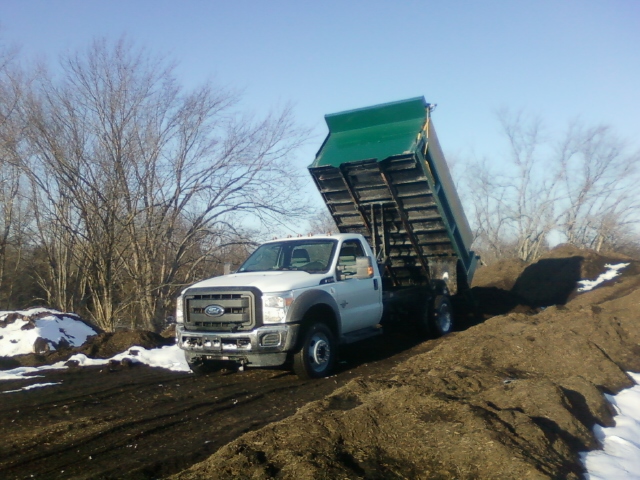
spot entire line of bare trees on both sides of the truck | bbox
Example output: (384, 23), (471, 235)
(0, 38), (640, 331)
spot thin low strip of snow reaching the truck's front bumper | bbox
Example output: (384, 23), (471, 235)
(0, 345), (191, 384)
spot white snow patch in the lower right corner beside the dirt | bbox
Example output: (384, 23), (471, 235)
(580, 373), (640, 480)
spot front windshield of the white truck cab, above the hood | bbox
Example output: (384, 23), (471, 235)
(238, 239), (338, 273)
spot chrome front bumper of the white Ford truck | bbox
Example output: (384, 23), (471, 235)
(176, 324), (300, 367)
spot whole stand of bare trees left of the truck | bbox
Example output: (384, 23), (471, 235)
(0, 38), (307, 331)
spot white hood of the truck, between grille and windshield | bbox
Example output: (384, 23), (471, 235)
(182, 271), (329, 293)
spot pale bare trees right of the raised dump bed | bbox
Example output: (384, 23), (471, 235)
(466, 111), (640, 261)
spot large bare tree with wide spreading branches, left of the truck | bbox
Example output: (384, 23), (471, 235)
(20, 39), (306, 330)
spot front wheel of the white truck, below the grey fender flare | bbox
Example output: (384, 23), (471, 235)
(293, 323), (337, 380)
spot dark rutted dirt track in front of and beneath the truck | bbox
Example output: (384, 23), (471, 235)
(0, 336), (429, 479)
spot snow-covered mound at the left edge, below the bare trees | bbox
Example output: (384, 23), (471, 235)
(0, 308), (97, 357)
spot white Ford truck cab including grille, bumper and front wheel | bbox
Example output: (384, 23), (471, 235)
(176, 234), (383, 378)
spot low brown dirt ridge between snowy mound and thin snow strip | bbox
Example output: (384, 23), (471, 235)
(5, 330), (175, 370)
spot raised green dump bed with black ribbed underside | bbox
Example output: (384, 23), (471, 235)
(309, 97), (476, 293)
